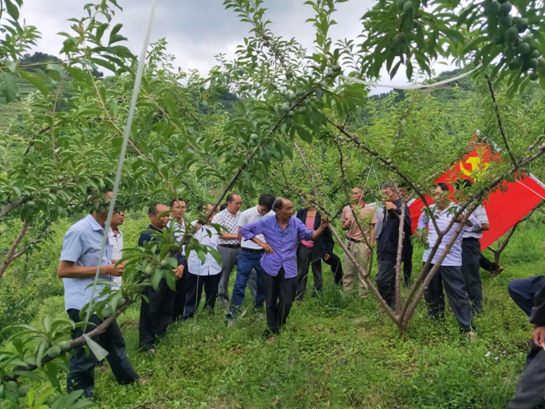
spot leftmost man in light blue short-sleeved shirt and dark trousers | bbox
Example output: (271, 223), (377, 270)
(57, 191), (138, 398)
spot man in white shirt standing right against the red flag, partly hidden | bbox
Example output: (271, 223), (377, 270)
(456, 179), (490, 314)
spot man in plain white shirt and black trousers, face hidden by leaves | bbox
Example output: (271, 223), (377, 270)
(183, 203), (221, 321)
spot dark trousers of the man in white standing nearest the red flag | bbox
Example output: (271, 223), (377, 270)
(462, 238), (483, 314)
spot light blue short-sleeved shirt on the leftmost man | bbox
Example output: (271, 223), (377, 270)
(60, 215), (112, 310)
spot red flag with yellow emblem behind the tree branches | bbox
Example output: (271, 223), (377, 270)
(409, 140), (545, 249)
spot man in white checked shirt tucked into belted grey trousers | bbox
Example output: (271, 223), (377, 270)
(212, 193), (242, 308)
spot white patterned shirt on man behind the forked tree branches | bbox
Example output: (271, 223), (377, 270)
(418, 202), (481, 266)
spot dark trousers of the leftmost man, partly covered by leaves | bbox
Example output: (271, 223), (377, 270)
(66, 309), (138, 398)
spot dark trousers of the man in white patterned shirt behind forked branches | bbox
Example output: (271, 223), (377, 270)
(424, 264), (472, 332)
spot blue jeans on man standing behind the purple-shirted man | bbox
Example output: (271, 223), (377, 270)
(230, 248), (265, 313)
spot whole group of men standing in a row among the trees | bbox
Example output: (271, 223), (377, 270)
(58, 181), (545, 407)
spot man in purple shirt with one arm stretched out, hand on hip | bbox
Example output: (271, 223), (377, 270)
(240, 198), (329, 334)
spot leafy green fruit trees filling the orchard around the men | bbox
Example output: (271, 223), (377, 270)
(0, 0), (545, 408)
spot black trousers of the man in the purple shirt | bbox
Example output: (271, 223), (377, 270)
(261, 268), (297, 334)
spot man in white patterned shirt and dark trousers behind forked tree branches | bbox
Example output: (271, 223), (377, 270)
(418, 183), (481, 337)
